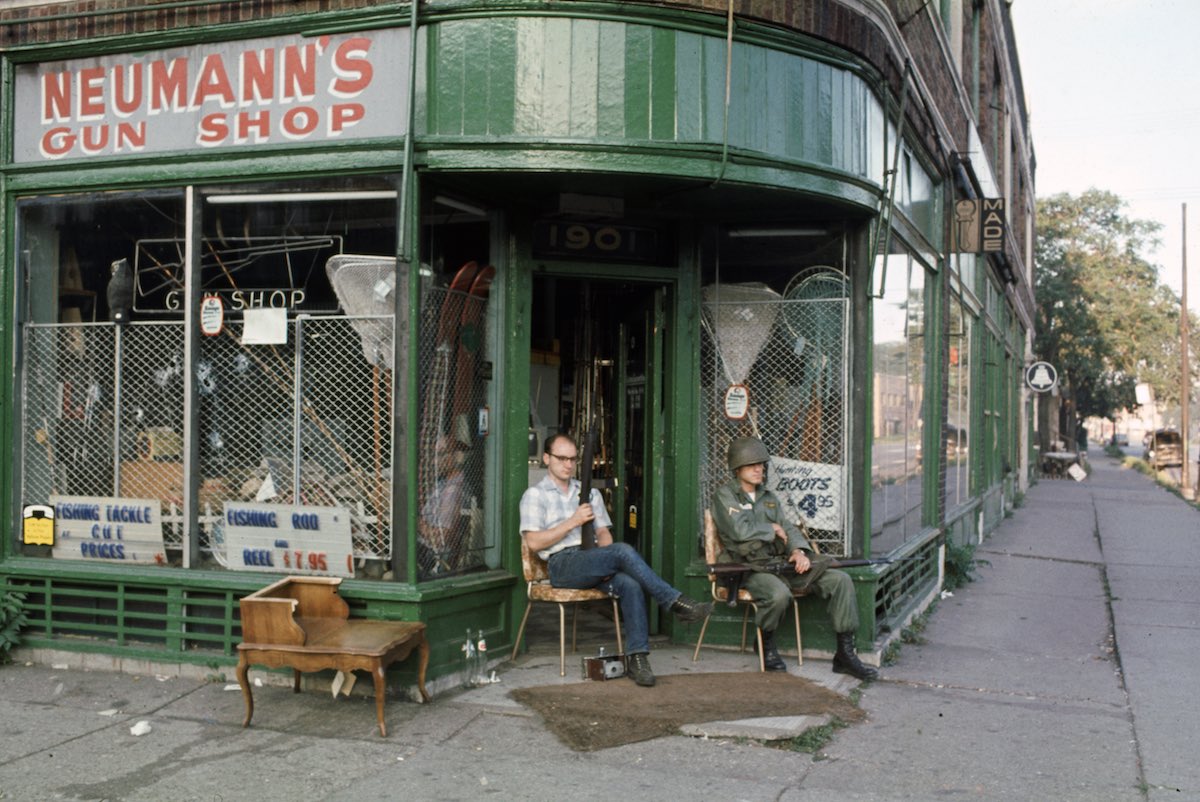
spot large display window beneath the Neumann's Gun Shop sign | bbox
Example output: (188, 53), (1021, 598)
(14, 175), (446, 579)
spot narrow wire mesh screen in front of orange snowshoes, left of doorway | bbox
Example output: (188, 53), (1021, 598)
(418, 282), (491, 577)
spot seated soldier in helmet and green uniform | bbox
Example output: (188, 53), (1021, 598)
(713, 437), (878, 680)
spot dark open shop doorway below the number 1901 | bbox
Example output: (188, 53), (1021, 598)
(529, 274), (670, 567)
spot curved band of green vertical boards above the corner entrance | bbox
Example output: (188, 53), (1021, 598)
(418, 17), (884, 180)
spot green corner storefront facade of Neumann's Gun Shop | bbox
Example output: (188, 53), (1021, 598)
(0, 1), (1028, 690)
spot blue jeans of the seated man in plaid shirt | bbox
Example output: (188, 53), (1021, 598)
(547, 543), (683, 654)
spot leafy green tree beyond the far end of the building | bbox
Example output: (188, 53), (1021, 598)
(1034, 188), (1180, 431)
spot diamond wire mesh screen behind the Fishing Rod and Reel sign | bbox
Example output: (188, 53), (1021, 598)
(194, 317), (392, 573)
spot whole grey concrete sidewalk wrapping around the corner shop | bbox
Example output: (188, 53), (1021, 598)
(0, 455), (1200, 802)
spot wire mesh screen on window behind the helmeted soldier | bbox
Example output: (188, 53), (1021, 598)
(697, 285), (850, 555)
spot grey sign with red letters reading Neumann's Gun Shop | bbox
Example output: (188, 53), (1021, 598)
(13, 28), (412, 163)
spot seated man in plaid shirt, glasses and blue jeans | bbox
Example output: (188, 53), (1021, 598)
(521, 435), (713, 687)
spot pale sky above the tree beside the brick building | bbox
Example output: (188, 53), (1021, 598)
(1012, 0), (1200, 304)
